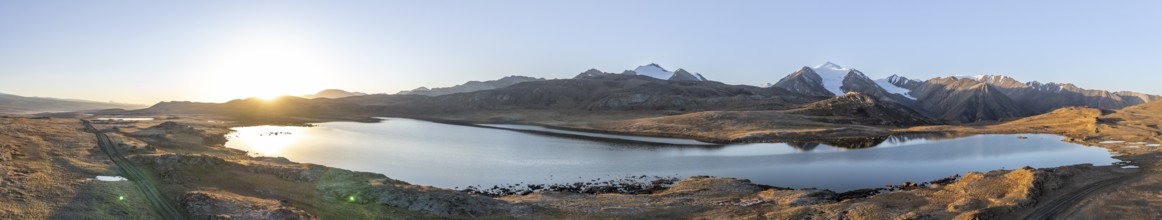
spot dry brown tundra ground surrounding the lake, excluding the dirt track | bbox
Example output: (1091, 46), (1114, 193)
(0, 102), (1162, 219)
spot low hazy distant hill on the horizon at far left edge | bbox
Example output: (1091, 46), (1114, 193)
(0, 93), (145, 114)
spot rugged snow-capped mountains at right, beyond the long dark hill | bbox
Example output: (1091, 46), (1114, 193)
(770, 62), (1162, 122)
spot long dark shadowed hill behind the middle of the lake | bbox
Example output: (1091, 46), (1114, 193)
(343, 73), (817, 114)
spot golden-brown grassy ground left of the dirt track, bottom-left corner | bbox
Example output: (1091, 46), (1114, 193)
(0, 119), (155, 219)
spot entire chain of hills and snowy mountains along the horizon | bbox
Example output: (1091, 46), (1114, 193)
(15, 62), (1162, 126)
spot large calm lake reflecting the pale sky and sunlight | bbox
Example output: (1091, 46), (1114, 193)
(227, 119), (1117, 191)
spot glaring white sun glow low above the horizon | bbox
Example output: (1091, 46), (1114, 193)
(191, 31), (344, 101)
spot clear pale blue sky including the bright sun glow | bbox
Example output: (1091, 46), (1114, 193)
(0, 0), (1162, 104)
